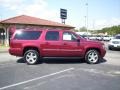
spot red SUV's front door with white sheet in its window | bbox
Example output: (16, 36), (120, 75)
(60, 31), (82, 57)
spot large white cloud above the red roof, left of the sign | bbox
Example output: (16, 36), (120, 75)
(0, 0), (60, 22)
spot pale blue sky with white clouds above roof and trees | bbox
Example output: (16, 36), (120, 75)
(0, 0), (120, 30)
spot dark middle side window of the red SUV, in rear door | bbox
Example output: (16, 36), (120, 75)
(45, 31), (59, 41)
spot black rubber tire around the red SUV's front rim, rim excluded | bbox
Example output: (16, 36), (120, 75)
(85, 49), (100, 64)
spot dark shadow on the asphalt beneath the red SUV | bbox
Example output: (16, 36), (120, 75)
(17, 58), (107, 64)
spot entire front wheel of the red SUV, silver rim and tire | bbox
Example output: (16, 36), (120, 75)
(85, 49), (100, 64)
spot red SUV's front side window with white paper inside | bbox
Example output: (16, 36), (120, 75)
(63, 32), (77, 41)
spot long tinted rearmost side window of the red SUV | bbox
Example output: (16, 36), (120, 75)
(14, 31), (42, 40)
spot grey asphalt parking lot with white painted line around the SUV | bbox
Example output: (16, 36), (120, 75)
(0, 42), (120, 90)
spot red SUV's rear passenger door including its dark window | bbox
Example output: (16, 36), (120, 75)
(42, 31), (61, 57)
